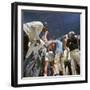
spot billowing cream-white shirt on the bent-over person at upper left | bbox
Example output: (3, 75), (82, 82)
(23, 21), (44, 42)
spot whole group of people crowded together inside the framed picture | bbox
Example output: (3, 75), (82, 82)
(23, 21), (80, 77)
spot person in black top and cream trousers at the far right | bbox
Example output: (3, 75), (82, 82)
(67, 31), (80, 75)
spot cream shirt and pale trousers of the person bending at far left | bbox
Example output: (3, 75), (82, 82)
(23, 21), (44, 58)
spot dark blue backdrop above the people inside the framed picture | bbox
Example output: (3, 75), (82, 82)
(22, 10), (80, 39)
